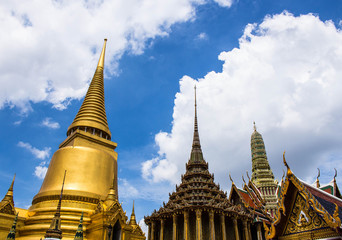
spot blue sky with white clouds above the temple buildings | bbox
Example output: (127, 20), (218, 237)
(0, 0), (342, 232)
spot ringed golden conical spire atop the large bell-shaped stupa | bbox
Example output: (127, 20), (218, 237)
(67, 39), (111, 140)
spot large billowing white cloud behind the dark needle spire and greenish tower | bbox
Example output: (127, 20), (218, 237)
(142, 12), (342, 188)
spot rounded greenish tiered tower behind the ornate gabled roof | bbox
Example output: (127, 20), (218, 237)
(251, 122), (277, 216)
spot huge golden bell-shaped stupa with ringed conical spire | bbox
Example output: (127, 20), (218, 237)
(0, 39), (145, 240)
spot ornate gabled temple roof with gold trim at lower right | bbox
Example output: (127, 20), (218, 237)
(265, 153), (342, 239)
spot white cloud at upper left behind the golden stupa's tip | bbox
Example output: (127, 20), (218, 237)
(0, 0), (230, 112)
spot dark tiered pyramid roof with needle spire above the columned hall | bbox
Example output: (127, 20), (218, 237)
(145, 87), (249, 221)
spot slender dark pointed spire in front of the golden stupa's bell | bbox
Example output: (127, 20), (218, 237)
(44, 170), (66, 239)
